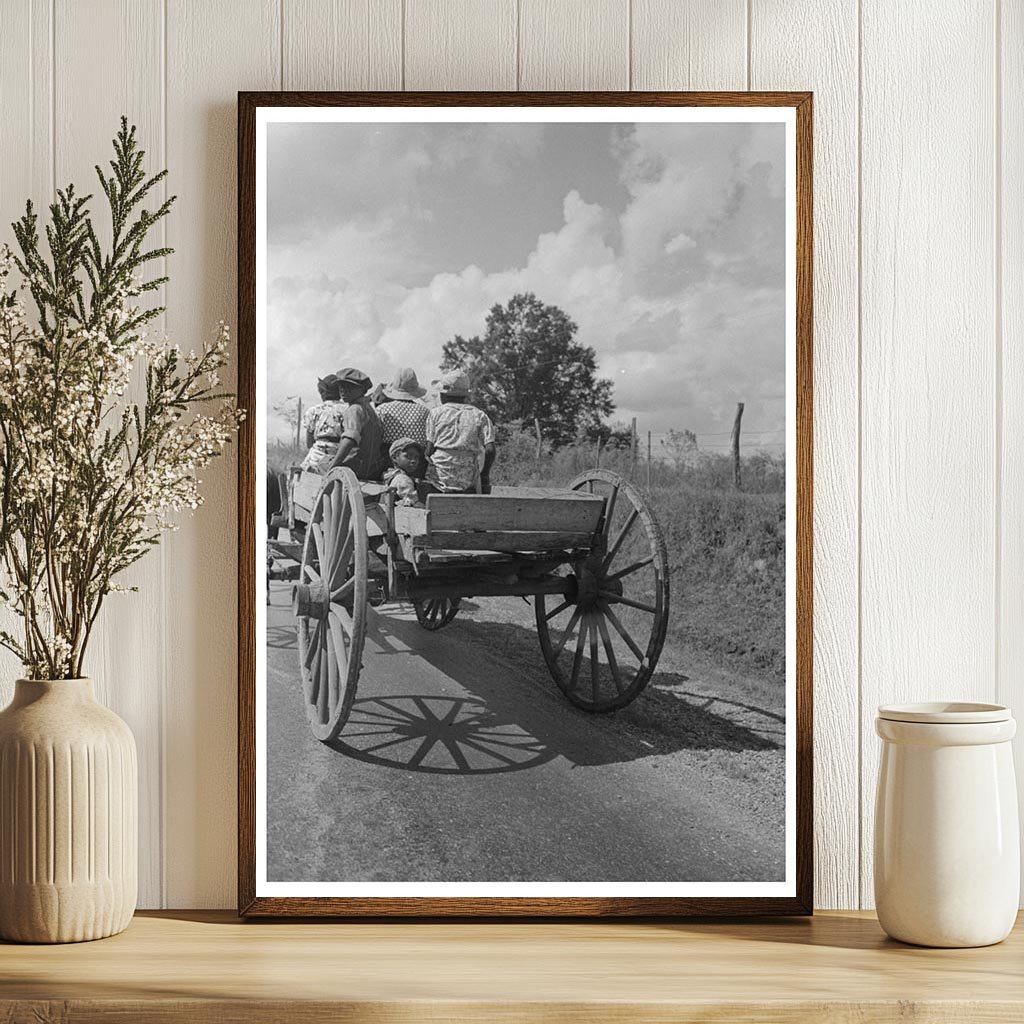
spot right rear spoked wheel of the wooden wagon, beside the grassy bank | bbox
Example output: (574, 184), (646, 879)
(535, 469), (669, 712)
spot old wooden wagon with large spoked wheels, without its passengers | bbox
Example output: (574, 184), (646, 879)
(270, 468), (669, 740)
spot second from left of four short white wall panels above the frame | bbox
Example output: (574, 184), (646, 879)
(403, 0), (516, 91)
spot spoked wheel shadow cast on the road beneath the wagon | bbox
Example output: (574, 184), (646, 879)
(328, 694), (556, 775)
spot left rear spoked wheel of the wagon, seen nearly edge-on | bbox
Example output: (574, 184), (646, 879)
(292, 468), (367, 741)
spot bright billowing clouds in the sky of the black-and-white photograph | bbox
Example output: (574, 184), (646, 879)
(268, 124), (784, 437)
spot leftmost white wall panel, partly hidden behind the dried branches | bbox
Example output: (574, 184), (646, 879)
(0, 0), (53, 708)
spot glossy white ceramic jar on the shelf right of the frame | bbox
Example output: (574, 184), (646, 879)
(874, 703), (1020, 947)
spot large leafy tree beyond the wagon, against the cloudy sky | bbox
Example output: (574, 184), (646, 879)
(441, 292), (614, 447)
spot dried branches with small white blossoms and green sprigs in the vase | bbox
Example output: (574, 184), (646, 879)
(0, 118), (242, 679)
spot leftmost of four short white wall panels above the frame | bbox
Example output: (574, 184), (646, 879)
(282, 0), (401, 90)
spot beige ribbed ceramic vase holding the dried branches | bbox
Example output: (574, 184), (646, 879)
(0, 679), (138, 942)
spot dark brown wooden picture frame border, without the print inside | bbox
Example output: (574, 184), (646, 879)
(238, 92), (813, 918)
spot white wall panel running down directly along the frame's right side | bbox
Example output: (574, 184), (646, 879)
(751, 0), (860, 907)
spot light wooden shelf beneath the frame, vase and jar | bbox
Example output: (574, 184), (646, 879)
(0, 911), (1024, 1024)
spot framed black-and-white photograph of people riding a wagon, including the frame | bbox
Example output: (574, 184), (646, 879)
(238, 92), (812, 916)
